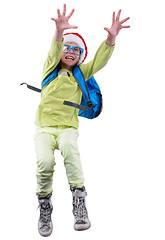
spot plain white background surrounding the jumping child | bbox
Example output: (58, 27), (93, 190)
(0, 0), (165, 240)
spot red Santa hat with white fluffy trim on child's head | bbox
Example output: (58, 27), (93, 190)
(63, 33), (88, 65)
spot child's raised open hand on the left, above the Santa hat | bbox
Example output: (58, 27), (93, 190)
(51, 4), (78, 31)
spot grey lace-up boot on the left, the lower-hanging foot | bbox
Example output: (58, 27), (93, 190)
(38, 193), (53, 237)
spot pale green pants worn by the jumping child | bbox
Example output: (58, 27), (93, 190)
(35, 126), (84, 196)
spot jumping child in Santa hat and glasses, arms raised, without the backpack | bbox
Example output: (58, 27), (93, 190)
(35, 4), (129, 236)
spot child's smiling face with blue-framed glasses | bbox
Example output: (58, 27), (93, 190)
(61, 42), (80, 70)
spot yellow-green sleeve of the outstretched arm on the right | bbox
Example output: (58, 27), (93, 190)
(80, 41), (115, 80)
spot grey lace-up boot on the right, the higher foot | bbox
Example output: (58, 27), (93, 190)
(71, 187), (91, 231)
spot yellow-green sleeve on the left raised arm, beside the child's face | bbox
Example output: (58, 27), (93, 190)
(42, 38), (64, 81)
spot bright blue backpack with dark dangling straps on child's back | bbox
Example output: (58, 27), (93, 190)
(21, 66), (102, 119)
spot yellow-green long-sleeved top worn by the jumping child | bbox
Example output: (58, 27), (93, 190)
(35, 38), (114, 129)
